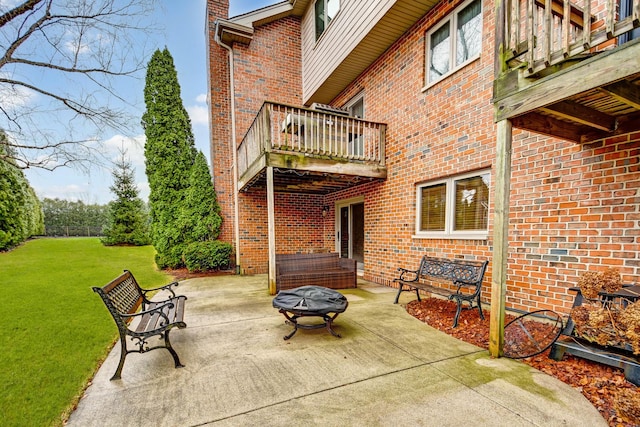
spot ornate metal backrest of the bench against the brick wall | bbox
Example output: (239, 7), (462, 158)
(419, 256), (488, 285)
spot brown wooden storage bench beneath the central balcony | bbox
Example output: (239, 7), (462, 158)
(276, 252), (357, 291)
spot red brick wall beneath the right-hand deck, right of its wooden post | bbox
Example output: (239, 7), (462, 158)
(507, 134), (640, 310)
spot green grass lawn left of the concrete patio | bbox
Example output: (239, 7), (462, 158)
(0, 238), (171, 426)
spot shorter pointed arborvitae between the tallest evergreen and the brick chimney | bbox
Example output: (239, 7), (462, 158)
(179, 151), (222, 243)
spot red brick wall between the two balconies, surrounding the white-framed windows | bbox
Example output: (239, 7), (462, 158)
(334, 2), (495, 295)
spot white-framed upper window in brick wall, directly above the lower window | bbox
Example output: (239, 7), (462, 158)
(424, 0), (482, 86)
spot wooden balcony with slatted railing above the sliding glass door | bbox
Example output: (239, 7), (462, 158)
(237, 102), (387, 194)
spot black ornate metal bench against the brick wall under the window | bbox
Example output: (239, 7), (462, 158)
(393, 255), (489, 328)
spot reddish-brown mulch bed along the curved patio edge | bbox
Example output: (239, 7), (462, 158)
(406, 298), (640, 427)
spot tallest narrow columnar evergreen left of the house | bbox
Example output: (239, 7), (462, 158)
(142, 48), (196, 268)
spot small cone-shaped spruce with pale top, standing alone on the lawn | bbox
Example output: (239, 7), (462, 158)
(101, 152), (151, 246)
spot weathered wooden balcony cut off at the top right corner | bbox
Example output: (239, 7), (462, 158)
(493, 0), (640, 143)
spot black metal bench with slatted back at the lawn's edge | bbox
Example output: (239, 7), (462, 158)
(92, 270), (187, 380)
